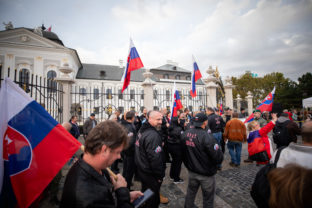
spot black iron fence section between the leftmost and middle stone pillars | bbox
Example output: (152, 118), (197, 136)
(70, 83), (144, 125)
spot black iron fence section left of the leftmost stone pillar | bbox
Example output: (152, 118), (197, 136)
(0, 66), (63, 123)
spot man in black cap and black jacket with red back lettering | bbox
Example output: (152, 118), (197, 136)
(181, 113), (223, 208)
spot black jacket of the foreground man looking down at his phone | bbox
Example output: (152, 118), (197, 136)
(60, 159), (133, 208)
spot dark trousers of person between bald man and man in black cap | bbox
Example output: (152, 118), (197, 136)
(168, 143), (182, 181)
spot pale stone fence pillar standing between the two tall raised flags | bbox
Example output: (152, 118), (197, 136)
(142, 69), (156, 111)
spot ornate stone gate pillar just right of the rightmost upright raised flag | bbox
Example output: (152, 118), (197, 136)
(203, 66), (218, 107)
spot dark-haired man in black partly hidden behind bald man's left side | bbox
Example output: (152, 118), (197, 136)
(120, 111), (137, 189)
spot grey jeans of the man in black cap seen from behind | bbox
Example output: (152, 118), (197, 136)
(184, 171), (216, 208)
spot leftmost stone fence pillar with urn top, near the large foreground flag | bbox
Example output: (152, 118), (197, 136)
(55, 64), (75, 122)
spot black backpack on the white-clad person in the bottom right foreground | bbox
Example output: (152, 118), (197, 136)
(250, 147), (285, 208)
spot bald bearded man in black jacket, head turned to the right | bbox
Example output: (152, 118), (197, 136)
(135, 111), (166, 208)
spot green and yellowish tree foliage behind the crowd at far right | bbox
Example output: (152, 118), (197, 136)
(232, 72), (312, 109)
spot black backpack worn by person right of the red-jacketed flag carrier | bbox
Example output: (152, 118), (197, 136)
(273, 120), (290, 147)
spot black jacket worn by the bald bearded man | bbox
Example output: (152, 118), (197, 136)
(135, 122), (166, 180)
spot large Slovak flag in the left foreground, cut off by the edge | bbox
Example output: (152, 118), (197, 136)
(0, 78), (81, 208)
